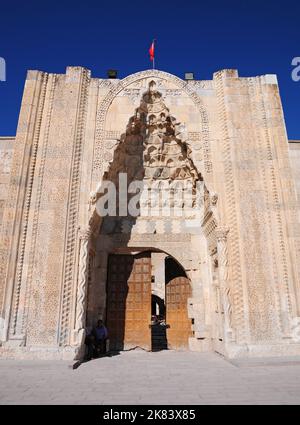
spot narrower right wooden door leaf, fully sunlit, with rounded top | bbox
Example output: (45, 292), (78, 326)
(166, 277), (192, 349)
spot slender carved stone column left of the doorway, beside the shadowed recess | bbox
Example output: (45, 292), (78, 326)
(74, 229), (92, 346)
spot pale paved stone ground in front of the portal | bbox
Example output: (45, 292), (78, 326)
(0, 351), (300, 404)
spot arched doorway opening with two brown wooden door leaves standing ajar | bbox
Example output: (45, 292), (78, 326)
(106, 251), (192, 351)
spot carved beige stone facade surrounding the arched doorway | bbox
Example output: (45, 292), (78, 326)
(0, 67), (300, 358)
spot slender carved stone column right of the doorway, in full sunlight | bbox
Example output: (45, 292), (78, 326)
(216, 227), (234, 342)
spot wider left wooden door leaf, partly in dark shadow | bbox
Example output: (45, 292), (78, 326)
(107, 253), (151, 350)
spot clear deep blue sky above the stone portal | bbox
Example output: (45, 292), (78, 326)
(0, 0), (300, 139)
